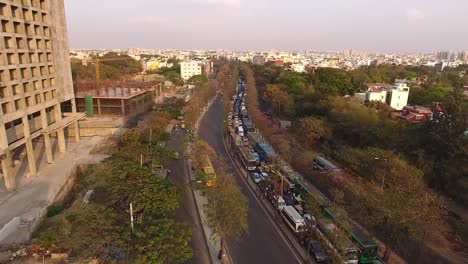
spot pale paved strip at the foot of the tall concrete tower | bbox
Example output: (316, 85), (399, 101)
(0, 137), (107, 243)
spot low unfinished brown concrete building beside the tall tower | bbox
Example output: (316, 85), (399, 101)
(75, 81), (162, 117)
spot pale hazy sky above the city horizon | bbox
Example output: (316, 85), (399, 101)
(65, 0), (468, 52)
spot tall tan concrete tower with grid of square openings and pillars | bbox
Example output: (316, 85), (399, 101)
(0, 0), (84, 191)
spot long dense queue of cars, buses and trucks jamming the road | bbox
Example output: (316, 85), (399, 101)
(227, 78), (382, 264)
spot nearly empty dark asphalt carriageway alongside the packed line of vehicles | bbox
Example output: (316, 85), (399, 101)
(199, 97), (299, 264)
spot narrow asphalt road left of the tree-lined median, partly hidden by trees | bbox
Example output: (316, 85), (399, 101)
(167, 129), (211, 264)
